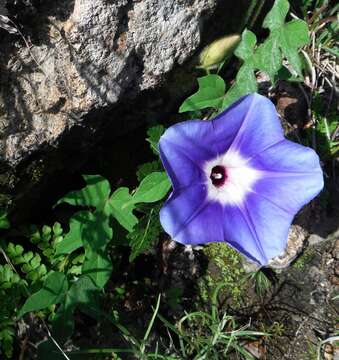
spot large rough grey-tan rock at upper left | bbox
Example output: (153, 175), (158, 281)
(0, 0), (218, 166)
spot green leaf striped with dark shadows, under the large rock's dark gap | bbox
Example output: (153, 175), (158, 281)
(57, 175), (111, 209)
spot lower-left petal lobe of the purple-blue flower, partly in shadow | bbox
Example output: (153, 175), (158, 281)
(160, 185), (224, 245)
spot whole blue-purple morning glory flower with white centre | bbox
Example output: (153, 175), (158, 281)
(159, 94), (323, 265)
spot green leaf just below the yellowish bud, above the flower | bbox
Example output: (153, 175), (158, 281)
(179, 74), (225, 113)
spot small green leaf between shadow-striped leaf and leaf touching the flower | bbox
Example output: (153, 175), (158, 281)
(109, 187), (138, 231)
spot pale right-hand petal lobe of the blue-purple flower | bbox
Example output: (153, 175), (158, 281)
(249, 140), (324, 215)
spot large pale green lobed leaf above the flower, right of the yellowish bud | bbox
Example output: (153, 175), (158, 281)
(222, 0), (309, 110)
